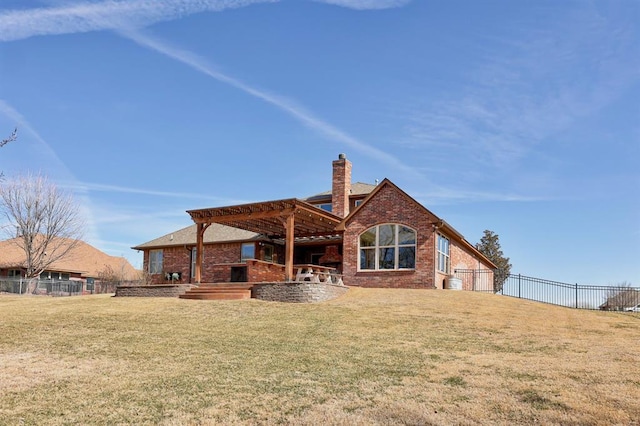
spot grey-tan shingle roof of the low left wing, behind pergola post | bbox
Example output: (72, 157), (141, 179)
(132, 223), (265, 250)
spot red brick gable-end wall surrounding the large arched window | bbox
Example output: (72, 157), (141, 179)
(342, 183), (436, 288)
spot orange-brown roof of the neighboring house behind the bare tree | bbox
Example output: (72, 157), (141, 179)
(0, 238), (138, 280)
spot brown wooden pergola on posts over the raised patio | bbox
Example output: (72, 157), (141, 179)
(187, 198), (342, 283)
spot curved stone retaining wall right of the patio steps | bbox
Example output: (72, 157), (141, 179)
(251, 282), (348, 303)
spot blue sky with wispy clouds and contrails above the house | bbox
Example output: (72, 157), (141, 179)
(0, 0), (640, 285)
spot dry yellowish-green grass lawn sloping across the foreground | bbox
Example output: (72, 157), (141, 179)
(0, 288), (640, 425)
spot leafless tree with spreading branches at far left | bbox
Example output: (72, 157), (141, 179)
(0, 175), (84, 290)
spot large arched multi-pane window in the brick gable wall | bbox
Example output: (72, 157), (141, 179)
(359, 224), (416, 270)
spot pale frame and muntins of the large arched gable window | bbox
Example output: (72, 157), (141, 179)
(358, 223), (418, 272)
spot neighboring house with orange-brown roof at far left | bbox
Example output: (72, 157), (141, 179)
(0, 238), (140, 292)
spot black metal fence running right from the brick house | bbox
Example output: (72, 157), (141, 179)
(455, 269), (640, 311)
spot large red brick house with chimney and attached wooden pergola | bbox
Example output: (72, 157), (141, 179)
(133, 154), (496, 290)
